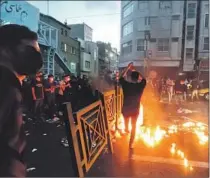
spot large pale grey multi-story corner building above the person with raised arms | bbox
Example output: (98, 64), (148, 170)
(119, 1), (184, 75)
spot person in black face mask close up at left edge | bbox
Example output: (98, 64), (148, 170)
(0, 24), (42, 177)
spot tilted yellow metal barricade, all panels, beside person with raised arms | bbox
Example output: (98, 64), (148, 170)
(64, 87), (123, 177)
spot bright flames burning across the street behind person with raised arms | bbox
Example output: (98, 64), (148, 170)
(116, 104), (208, 171)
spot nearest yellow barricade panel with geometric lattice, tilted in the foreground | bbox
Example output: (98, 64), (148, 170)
(64, 101), (111, 177)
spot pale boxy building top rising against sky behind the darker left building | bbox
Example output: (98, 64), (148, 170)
(69, 23), (93, 41)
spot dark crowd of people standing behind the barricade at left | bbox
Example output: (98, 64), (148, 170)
(22, 72), (115, 122)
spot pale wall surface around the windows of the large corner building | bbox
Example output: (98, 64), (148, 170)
(119, 1), (184, 67)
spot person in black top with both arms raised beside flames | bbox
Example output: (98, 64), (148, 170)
(119, 63), (146, 149)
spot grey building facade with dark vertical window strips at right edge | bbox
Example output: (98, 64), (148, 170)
(183, 1), (209, 78)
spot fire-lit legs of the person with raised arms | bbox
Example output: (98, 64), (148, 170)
(122, 111), (139, 145)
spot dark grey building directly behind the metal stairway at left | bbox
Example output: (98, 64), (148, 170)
(40, 14), (80, 76)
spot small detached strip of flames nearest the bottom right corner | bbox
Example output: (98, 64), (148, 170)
(170, 143), (193, 171)
